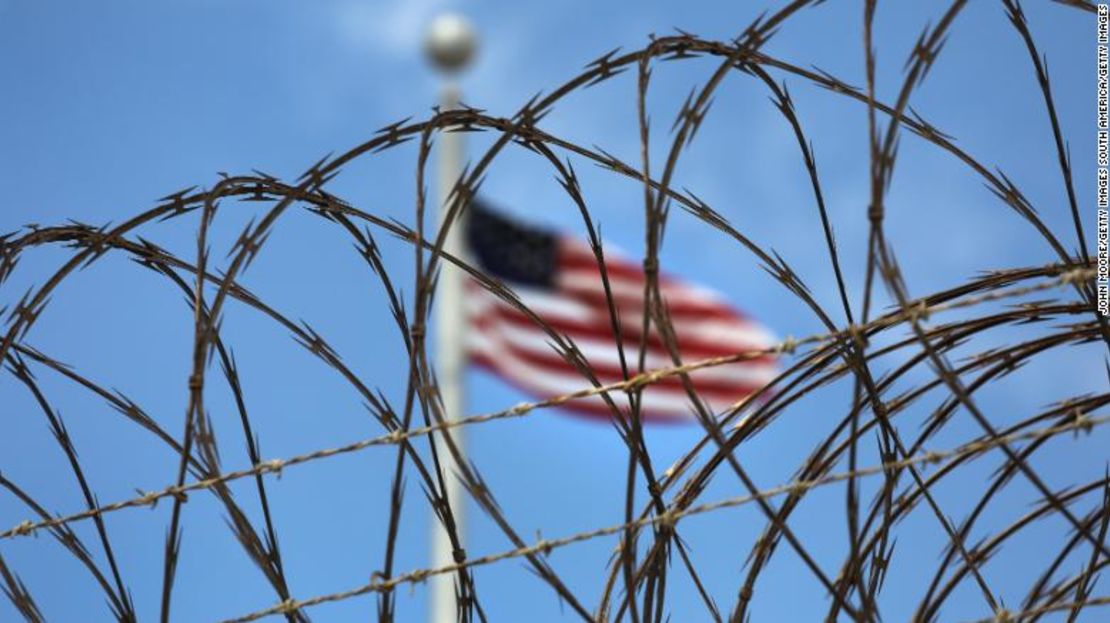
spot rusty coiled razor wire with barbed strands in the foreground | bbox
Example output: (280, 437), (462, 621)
(0, 0), (1110, 622)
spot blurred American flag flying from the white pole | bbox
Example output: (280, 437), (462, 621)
(464, 202), (777, 421)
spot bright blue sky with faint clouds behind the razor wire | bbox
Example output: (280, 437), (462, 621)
(0, 0), (1107, 621)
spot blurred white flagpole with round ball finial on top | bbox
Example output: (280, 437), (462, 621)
(426, 13), (475, 623)
